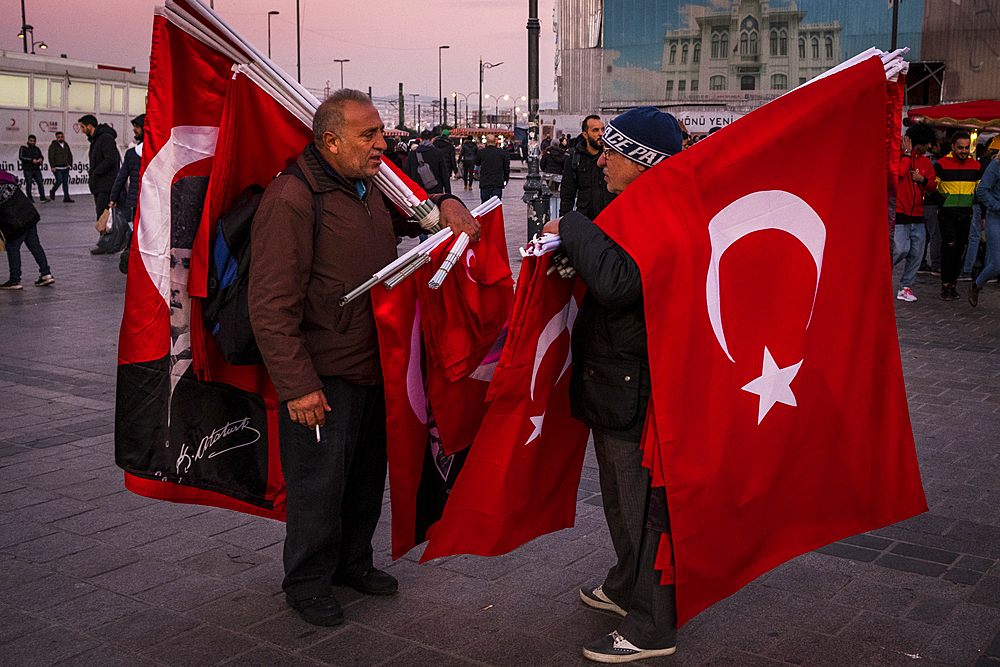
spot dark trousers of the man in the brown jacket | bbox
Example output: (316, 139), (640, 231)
(278, 377), (386, 600)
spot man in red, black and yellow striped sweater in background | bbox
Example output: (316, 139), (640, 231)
(934, 131), (979, 301)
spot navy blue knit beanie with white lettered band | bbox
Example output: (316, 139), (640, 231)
(603, 107), (682, 167)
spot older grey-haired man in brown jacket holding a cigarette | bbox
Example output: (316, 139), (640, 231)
(249, 89), (479, 625)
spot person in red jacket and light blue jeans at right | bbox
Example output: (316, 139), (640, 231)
(892, 123), (938, 301)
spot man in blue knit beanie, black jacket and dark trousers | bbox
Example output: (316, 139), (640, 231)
(545, 107), (682, 663)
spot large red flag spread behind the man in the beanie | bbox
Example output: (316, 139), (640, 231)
(588, 58), (927, 624)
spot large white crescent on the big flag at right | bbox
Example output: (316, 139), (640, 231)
(705, 190), (826, 361)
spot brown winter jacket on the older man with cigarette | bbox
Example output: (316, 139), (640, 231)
(249, 144), (421, 401)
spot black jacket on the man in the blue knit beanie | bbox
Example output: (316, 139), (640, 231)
(559, 212), (652, 442)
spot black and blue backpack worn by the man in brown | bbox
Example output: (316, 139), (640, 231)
(201, 163), (323, 366)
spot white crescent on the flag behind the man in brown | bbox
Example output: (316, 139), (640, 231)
(135, 125), (219, 307)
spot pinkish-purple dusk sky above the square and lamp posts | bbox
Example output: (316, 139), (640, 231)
(7, 0), (556, 107)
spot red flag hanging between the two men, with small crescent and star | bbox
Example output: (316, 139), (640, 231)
(421, 256), (589, 562)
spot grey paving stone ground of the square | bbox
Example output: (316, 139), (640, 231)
(0, 181), (1000, 667)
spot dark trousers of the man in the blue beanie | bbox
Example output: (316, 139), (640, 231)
(594, 431), (677, 649)
